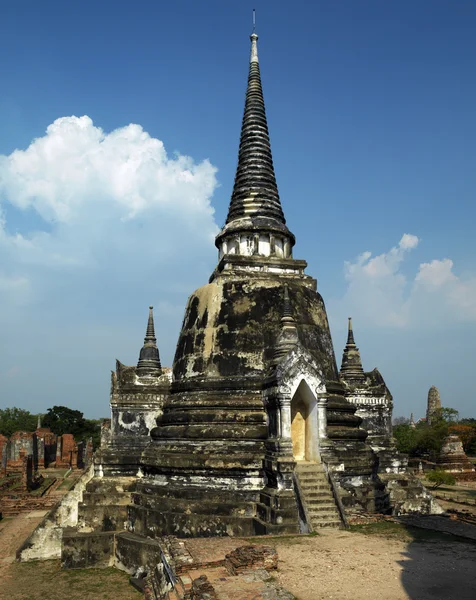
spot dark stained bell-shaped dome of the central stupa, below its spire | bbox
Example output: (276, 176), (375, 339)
(174, 274), (338, 382)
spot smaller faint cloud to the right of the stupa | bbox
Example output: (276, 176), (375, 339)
(333, 233), (476, 327)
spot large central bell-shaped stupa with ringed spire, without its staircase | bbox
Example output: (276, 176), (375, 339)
(126, 25), (385, 536)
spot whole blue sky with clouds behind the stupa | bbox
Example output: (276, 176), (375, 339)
(0, 0), (476, 417)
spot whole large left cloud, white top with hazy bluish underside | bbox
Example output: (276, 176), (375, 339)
(0, 116), (217, 302)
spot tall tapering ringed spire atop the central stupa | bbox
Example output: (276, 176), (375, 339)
(216, 22), (295, 257)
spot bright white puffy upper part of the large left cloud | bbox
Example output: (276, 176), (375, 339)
(0, 116), (216, 223)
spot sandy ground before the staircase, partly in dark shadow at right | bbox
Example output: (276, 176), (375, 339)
(273, 530), (476, 600)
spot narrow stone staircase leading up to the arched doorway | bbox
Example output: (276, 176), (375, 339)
(295, 462), (342, 531)
